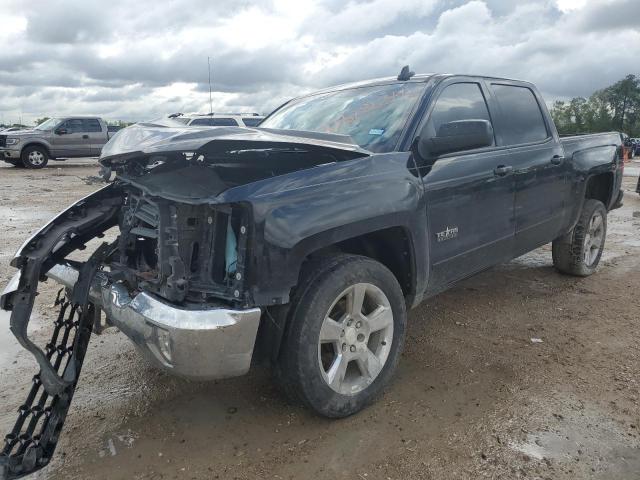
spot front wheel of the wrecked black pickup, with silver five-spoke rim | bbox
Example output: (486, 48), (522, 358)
(275, 254), (407, 418)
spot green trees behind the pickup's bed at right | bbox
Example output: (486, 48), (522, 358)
(551, 75), (640, 137)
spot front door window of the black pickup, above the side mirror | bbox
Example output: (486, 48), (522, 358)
(426, 83), (495, 145)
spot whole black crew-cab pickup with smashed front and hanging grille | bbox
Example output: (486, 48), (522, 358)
(0, 69), (622, 479)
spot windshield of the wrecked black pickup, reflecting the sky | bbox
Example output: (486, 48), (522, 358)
(260, 82), (425, 153)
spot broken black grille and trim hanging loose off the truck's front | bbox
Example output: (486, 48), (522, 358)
(0, 193), (117, 480)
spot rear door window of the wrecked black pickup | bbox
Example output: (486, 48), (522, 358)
(490, 83), (550, 146)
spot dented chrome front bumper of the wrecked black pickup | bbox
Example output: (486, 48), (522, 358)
(7, 265), (261, 380)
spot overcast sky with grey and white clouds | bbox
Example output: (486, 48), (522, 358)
(0, 0), (640, 123)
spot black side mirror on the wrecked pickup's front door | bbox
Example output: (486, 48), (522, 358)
(418, 120), (493, 159)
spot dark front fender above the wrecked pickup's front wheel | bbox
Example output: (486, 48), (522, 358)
(242, 153), (426, 305)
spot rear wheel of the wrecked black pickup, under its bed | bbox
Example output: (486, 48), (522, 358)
(552, 199), (607, 277)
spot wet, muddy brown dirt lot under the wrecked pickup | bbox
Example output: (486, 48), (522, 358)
(0, 160), (640, 480)
